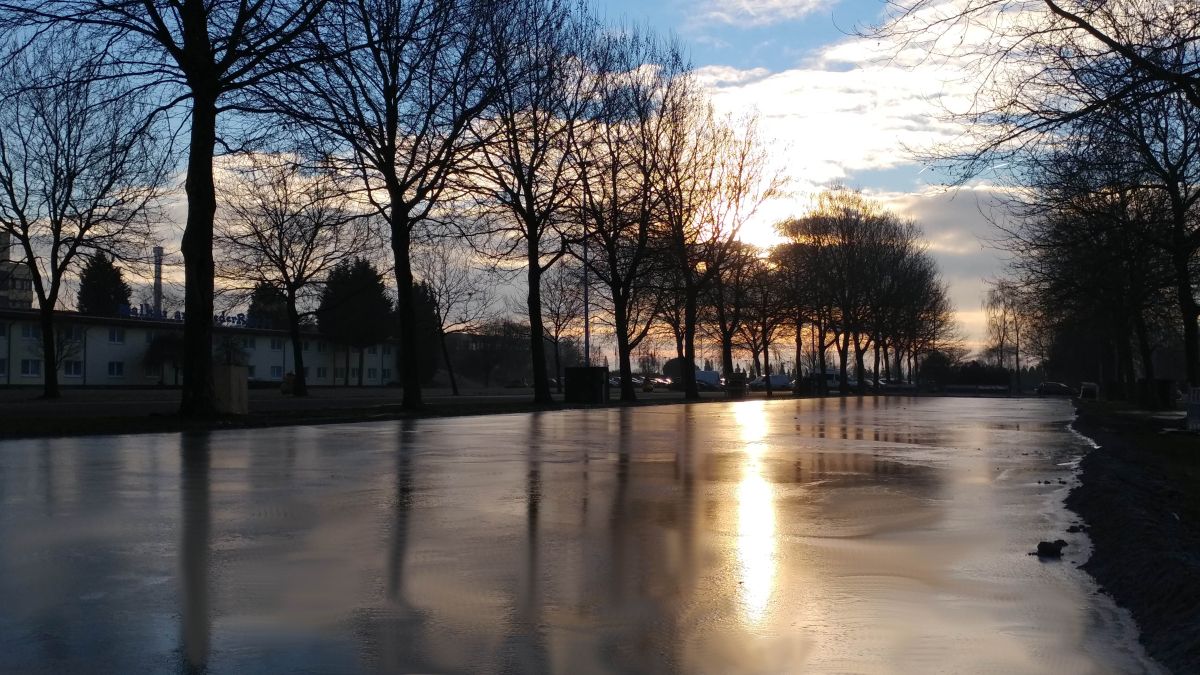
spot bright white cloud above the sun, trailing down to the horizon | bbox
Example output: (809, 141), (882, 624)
(697, 21), (1022, 347)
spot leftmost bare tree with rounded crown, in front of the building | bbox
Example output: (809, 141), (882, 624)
(0, 42), (167, 399)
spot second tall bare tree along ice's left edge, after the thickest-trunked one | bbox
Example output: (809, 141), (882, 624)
(264, 0), (496, 410)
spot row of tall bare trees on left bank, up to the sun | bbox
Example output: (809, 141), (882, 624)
(0, 0), (774, 414)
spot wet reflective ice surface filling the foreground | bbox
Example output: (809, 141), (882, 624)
(0, 398), (1156, 674)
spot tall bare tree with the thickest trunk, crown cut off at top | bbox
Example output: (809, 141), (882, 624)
(0, 0), (326, 416)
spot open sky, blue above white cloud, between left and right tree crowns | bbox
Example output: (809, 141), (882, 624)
(599, 0), (1003, 346)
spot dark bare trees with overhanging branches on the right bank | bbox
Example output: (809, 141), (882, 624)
(877, 0), (1200, 402)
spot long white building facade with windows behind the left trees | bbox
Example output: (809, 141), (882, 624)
(0, 309), (398, 387)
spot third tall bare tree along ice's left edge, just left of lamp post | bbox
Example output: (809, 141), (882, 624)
(470, 0), (599, 404)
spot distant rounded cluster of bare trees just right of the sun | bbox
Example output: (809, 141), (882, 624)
(704, 189), (956, 392)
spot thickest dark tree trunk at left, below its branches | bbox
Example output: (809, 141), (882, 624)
(179, 89), (217, 417)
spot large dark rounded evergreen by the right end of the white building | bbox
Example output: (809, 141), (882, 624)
(317, 258), (392, 386)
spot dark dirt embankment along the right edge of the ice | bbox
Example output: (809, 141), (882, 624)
(1067, 408), (1200, 673)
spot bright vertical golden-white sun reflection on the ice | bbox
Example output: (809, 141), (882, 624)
(734, 401), (775, 625)
